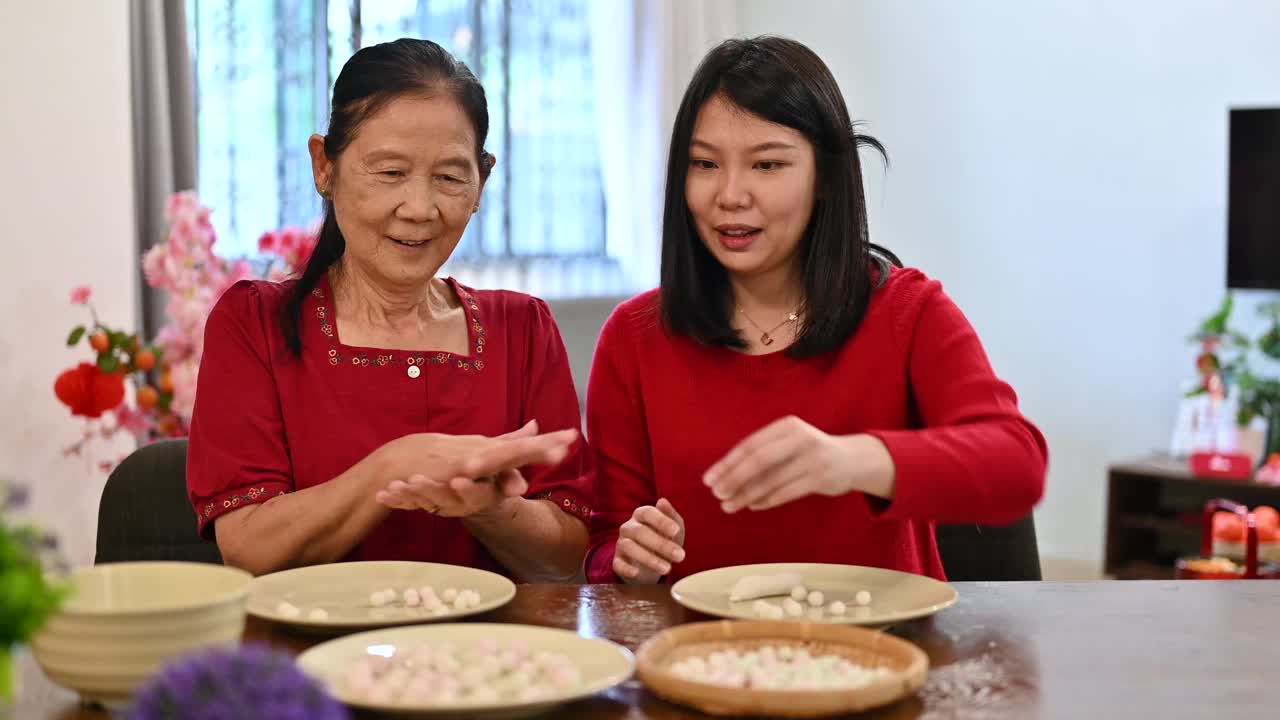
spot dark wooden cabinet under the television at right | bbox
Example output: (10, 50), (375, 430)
(1103, 456), (1280, 580)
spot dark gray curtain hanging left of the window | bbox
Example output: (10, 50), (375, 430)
(129, 0), (196, 336)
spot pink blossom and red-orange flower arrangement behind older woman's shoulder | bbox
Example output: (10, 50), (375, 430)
(54, 192), (316, 471)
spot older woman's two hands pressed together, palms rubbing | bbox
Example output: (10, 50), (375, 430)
(376, 421), (577, 518)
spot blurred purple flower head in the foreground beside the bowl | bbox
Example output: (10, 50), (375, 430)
(129, 638), (349, 720)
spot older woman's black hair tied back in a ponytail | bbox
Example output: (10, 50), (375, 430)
(280, 38), (493, 355)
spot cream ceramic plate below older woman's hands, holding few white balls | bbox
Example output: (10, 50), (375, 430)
(247, 561), (516, 632)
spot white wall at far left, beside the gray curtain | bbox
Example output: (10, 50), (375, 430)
(0, 0), (138, 564)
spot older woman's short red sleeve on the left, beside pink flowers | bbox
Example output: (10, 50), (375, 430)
(187, 281), (293, 537)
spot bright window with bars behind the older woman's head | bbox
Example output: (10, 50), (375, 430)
(187, 0), (609, 280)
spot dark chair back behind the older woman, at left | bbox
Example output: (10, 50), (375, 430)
(93, 439), (223, 565)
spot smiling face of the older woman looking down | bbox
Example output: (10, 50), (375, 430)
(311, 94), (484, 286)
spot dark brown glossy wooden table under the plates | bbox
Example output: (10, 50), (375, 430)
(15, 580), (1280, 720)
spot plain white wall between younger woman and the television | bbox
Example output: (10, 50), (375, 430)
(739, 0), (1280, 561)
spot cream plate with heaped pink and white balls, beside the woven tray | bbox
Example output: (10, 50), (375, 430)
(297, 623), (635, 719)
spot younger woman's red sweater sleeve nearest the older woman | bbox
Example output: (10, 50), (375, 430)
(584, 304), (658, 583)
